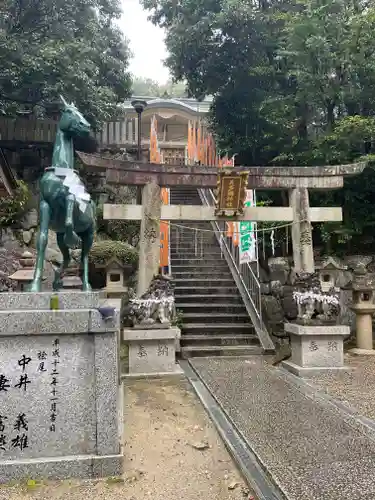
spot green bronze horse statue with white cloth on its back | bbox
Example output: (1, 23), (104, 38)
(30, 98), (96, 292)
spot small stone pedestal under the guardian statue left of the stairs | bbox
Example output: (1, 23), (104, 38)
(123, 325), (181, 377)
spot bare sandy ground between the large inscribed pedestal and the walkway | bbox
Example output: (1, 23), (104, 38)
(0, 380), (254, 500)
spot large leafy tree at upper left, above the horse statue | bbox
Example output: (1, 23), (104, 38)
(0, 0), (131, 123)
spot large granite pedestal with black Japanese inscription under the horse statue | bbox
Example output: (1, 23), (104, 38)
(0, 292), (122, 482)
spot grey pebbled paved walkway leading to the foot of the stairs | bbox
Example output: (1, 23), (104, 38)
(191, 357), (375, 500)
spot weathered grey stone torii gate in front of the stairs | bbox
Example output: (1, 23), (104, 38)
(78, 153), (365, 295)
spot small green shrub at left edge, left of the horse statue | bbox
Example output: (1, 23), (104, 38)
(0, 181), (31, 228)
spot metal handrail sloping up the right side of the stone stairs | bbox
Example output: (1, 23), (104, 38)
(198, 189), (274, 351)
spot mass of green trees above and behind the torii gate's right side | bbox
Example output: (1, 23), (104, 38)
(143, 0), (375, 252)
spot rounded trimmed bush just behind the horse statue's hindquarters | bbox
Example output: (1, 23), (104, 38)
(89, 240), (138, 268)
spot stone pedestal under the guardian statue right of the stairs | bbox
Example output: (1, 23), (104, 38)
(282, 323), (350, 377)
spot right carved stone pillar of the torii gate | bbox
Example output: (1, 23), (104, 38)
(289, 188), (315, 273)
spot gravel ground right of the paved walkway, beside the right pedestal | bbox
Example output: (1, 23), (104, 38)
(309, 354), (375, 420)
